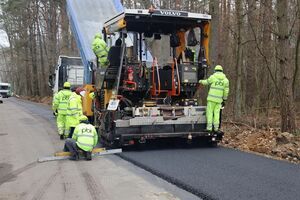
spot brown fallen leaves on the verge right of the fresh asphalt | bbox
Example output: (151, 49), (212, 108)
(221, 124), (300, 163)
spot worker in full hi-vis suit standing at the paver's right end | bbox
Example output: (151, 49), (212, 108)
(199, 65), (229, 132)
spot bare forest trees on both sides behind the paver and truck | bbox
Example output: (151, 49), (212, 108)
(0, 0), (300, 134)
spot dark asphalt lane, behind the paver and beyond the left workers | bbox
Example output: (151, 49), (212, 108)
(0, 99), (300, 200)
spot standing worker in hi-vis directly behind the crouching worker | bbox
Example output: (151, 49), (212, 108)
(67, 87), (85, 138)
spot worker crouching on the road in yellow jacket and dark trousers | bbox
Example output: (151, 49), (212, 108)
(64, 115), (98, 160)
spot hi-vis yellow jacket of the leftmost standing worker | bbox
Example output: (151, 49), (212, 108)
(52, 89), (72, 115)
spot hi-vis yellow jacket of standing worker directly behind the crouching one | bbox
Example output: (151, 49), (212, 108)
(67, 92), (82, 127)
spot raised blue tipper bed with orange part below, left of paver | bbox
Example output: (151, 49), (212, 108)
(66, 0), (123, 121)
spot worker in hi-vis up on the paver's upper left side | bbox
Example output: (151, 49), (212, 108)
(92, 33), (109, 68)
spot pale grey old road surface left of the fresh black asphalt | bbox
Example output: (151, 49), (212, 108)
(0, 98), (199, 200)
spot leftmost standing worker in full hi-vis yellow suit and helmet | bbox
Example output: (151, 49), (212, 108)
(52, 82), (72, 140)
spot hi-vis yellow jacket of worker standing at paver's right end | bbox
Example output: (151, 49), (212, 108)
(200, 72), (229, 103)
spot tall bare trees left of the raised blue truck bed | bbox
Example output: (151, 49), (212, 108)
(1, 0), (69, 95)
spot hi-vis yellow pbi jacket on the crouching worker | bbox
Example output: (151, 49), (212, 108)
(72, 123), (98, 151)
